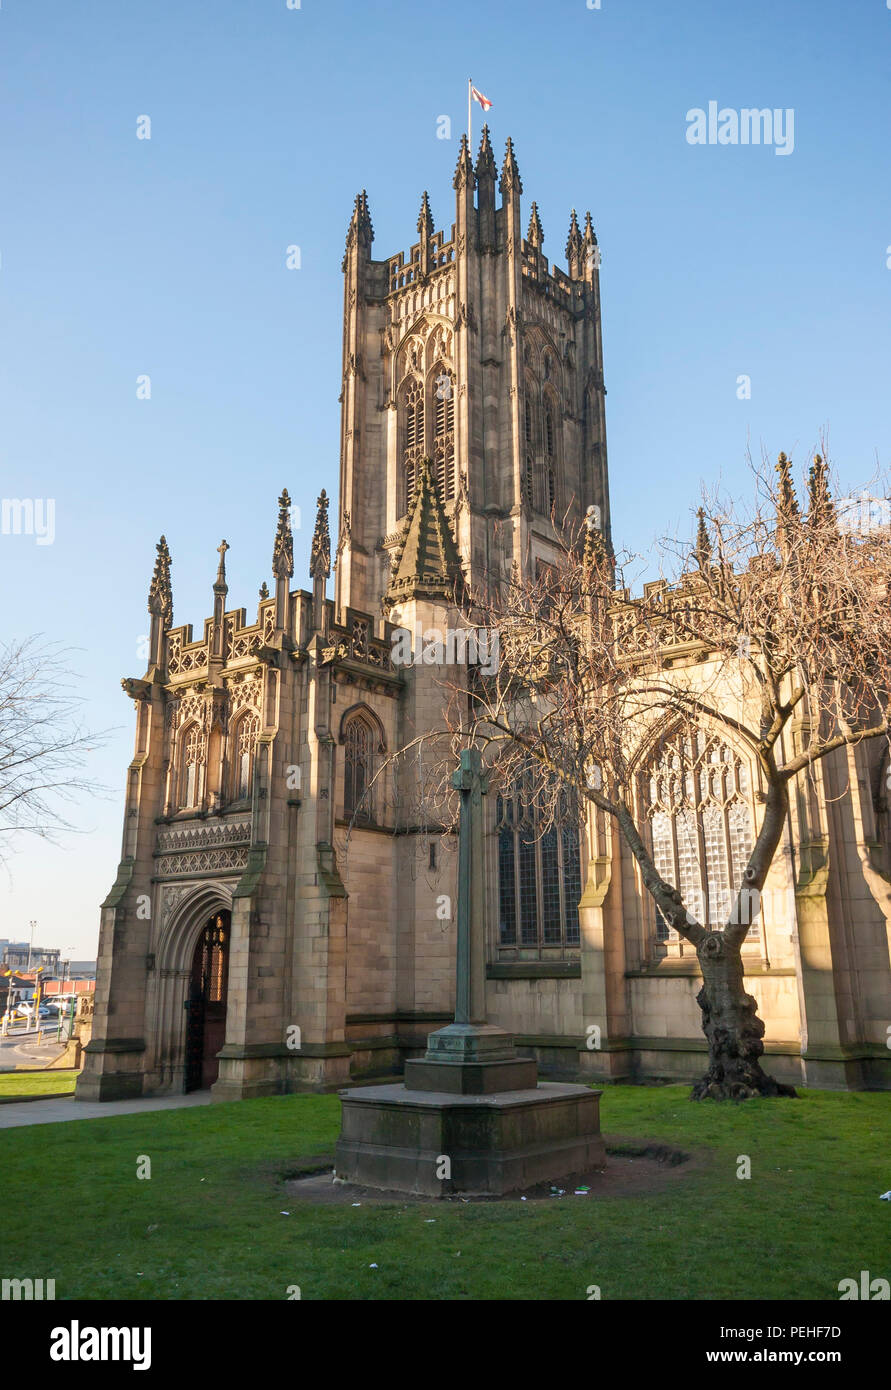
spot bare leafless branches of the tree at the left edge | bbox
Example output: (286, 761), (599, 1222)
(0, 637), (104, 860)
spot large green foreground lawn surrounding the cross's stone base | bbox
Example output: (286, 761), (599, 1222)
(0, 1086), (891, 1301)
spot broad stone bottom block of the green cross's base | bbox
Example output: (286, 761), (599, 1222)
(335, 1063), (606, 1197)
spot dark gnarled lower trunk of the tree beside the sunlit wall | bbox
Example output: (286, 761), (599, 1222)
(691, 931), (795, 1101)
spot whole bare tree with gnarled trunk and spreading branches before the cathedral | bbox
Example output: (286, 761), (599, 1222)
(433, 455), (891, 1099)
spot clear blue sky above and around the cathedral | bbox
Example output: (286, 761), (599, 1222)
(0, 0), (891, 956)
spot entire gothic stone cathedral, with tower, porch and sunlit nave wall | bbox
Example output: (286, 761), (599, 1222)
(78, 129), (891, 1099)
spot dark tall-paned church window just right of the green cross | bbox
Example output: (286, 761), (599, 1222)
(495, 778), (581, 958)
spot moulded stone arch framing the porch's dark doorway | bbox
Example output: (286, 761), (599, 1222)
(153, 883), (232, 1091)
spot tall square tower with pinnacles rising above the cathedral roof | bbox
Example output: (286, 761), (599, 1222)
(336, 126), (609, 631)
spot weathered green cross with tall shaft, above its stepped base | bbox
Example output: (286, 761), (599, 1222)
(452, 748), (489, 1023)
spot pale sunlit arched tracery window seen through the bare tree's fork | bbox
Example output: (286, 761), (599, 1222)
(641, 731), (759, 941)
